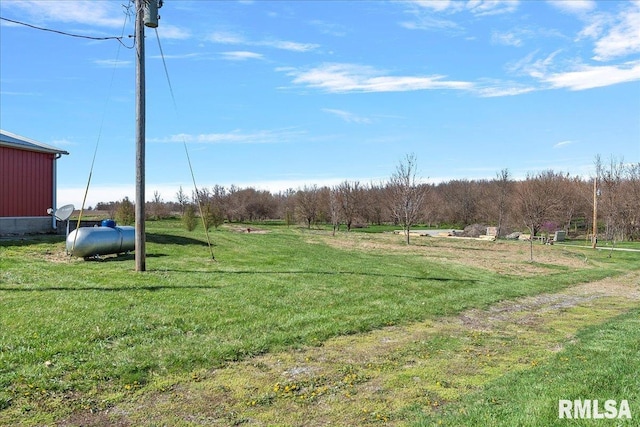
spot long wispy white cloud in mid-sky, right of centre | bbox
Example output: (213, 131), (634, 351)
(287, 63), (473, 93)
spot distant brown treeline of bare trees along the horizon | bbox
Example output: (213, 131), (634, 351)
(94, 156), (640, 244)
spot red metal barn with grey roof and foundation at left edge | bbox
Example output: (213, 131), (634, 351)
(0, 129), (69, 235)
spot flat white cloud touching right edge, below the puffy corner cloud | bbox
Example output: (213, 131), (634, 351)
(541, 61), (640, 90)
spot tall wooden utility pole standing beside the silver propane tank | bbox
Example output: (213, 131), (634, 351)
(135, 0), (146, 271)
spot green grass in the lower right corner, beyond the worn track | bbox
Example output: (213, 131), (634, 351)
(414, 309), (640, 427)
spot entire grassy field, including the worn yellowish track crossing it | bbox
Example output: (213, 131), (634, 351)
(0, 221), (640, 426)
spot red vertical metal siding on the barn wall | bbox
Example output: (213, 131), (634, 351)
(0, 147), (55, 217)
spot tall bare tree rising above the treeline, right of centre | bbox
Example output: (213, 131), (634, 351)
(388, 154), (429, 245)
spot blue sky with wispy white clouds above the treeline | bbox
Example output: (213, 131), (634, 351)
(0, 0), (640, 207)
